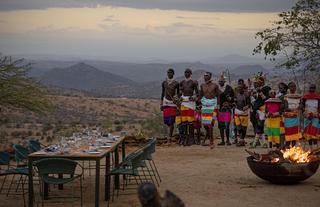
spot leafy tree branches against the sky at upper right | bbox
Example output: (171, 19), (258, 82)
(253, 0), (320, 87)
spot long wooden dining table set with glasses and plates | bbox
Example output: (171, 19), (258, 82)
(28, 137), (126, 207)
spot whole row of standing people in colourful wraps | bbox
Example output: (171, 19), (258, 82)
(160, 68), (320, 148)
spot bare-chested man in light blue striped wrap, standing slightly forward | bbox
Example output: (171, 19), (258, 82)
(199, 72), (221, 149)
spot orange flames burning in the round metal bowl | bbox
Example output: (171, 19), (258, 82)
(281, 146), (311, 163)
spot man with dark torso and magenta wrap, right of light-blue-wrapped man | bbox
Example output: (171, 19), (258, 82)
(218, 75), (234, 145)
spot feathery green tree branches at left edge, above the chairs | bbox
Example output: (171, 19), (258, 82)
(0, 54), (50, 113)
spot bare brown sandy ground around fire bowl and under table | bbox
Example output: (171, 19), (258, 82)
(0, 142), (320, 207)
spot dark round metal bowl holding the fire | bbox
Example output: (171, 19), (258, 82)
(247, 156), (320, 184)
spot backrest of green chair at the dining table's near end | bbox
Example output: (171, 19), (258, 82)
(34, 158), (78, 176)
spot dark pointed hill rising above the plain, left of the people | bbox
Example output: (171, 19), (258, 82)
(40, 63), (148, 97)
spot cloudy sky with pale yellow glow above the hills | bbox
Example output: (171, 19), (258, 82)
(0, 0), (295, 61)
